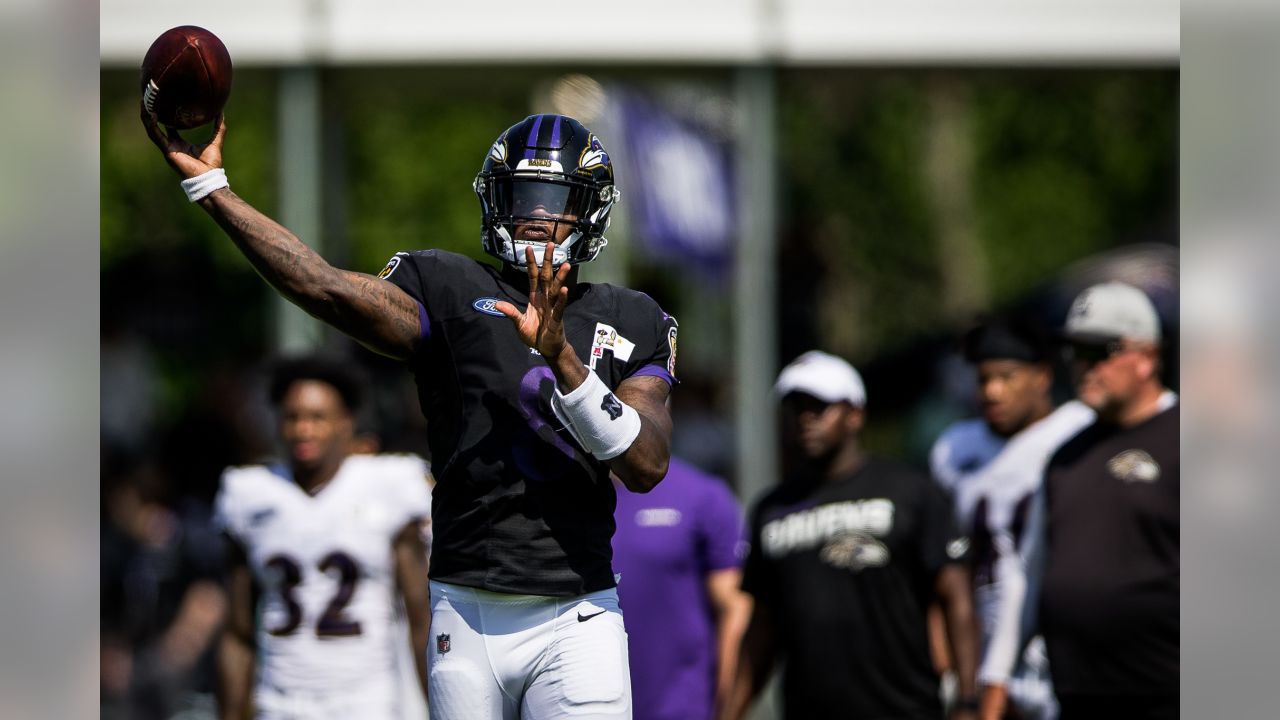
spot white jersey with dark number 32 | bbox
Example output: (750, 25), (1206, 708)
(215, 455), (431, 693)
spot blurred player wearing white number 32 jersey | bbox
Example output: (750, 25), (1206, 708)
(209, 357), (431, 720)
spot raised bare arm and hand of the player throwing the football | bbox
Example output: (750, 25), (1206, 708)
(142, 108), (421, 359)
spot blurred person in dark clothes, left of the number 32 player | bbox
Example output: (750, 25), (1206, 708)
(101, 461), (227, 720)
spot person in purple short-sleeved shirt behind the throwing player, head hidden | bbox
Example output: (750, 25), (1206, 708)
(613, 457), (750, 720)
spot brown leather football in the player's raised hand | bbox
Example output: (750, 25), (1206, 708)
(141, 26), (232, 129)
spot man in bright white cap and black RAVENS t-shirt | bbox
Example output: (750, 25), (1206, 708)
(722, 351), (977, 720)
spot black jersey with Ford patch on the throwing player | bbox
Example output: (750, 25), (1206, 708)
(380, 250), (676, 597)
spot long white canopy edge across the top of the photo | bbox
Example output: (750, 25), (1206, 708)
(100, 0), (1179, 67)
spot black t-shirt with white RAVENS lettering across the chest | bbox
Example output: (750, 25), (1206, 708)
(742, 459), (968, 720)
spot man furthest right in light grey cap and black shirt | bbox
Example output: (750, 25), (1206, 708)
(1028, 282), (1180, 720)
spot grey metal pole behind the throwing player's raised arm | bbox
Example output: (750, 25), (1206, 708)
(275, 65), (324, 354)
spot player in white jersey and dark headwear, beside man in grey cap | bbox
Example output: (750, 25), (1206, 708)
(929, 320), (1093, 720)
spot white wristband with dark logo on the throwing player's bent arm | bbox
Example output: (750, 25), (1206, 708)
(552, 370), (640, 460)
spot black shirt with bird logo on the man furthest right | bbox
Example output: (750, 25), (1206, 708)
(1041, 405), (1180, 694)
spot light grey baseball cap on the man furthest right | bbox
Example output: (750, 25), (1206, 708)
(1064, 282), (1160, 342)
